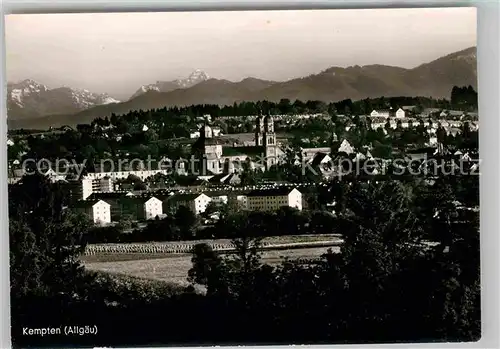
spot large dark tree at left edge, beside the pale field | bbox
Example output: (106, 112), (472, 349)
(9, 174), (91, 315)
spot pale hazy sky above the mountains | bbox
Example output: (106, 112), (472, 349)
(5, 8), (477, 99)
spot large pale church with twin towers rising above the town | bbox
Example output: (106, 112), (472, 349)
(192, 114), (285, 175)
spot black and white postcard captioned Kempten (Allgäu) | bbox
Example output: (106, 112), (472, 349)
(5, 8), (481, 348)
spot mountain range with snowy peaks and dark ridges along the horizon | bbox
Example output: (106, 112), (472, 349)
(8, 47), (477, 128)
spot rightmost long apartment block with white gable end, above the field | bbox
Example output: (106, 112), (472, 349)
(246, 188), (302, 211)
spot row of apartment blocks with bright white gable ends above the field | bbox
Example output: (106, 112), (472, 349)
(72, 187), (303, 225)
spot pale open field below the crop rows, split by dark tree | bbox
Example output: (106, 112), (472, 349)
(84, 247), (339, 285)
